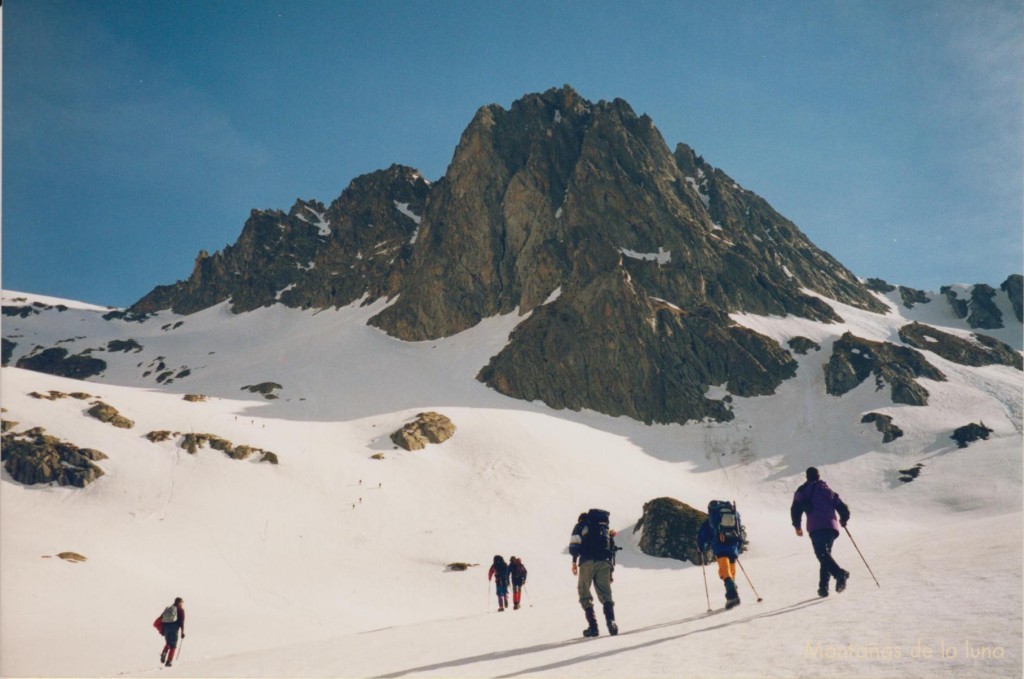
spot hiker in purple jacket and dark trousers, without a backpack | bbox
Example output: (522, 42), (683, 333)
(790, 467), (850, 596)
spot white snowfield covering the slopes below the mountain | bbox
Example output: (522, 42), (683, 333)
(0, 284), (1024, 677)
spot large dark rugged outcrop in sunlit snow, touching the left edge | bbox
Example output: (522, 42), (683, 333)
(0, 428), (106, 487)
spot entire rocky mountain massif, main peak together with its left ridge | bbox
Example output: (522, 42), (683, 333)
(123, 86), (1011, 422)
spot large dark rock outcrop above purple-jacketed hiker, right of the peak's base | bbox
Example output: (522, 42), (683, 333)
(825, 332), (946, 406)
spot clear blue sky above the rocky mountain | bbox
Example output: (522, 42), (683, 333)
(2, 0), (1024, 305)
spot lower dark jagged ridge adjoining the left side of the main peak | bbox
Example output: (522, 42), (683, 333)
(129, 165), (429, 314)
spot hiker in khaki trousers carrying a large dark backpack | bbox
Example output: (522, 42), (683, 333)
(569, 509), (618, 637)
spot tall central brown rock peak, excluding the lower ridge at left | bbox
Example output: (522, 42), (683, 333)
(371, 87), (882, 422)
